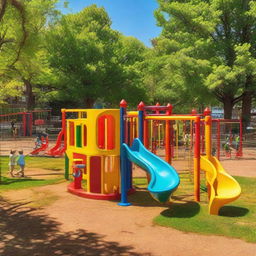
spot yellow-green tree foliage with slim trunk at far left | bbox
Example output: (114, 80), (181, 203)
(0, 0), (58, 109)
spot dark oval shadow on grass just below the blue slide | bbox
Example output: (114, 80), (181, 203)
(161, 201), (200, 218)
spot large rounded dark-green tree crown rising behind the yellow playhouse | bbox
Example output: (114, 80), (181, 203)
(47, 5), (145, 107)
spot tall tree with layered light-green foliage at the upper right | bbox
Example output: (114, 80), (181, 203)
(154, 0), (256, 118)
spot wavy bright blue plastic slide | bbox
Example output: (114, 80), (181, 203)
(122, 139), (180, 203)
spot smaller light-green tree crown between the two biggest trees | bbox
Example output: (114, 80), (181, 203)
(141, 45), (214, 111)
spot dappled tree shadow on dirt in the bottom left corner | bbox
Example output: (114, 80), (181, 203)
(0, 198), (151, 256)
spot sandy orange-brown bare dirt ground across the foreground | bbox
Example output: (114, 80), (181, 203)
(0, 139), (256, 256)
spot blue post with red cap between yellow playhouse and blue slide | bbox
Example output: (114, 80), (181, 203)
(118, 100), (131, 206)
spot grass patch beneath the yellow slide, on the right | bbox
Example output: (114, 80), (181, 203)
(133, 174), (256, 243)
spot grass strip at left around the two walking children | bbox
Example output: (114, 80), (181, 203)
(0, 156), (64, 191)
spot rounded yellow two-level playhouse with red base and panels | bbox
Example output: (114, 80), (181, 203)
(62, 109), (120, 200)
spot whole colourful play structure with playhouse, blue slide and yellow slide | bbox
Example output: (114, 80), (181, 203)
(63, 100), (241, 214)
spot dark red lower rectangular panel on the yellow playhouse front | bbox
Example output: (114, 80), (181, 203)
(90, 156), (101, 193)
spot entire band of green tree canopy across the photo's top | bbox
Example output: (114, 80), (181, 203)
(0, 0), (256, 122)
